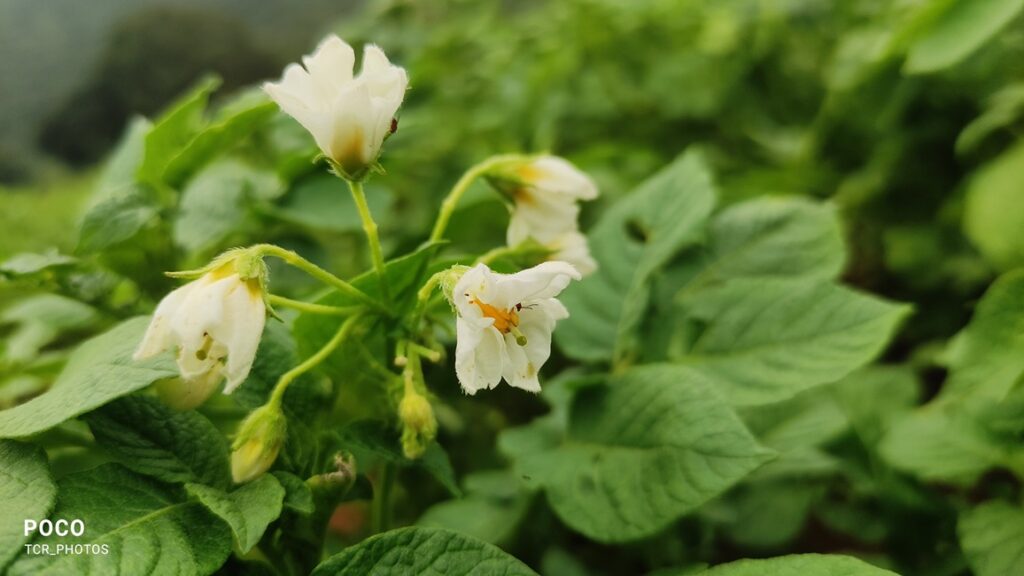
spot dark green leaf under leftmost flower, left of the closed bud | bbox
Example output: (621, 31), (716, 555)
(85, 396), (231, 488)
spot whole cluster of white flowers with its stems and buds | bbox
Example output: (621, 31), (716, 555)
(135, 36), (597, 483)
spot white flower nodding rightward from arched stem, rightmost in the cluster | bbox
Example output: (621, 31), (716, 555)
(499, 156), (597, 276)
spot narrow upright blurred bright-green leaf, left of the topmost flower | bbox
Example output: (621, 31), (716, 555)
(136, 77), (220, 184)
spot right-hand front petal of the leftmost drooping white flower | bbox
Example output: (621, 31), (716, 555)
(217, 282), (266, 394)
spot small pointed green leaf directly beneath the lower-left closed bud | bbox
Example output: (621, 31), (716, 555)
(185, 474), (285, 553)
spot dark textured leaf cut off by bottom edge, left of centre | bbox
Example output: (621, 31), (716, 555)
(312, 528), (536, 576)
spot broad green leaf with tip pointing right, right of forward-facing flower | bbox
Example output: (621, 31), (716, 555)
(680, 278), (910, 405)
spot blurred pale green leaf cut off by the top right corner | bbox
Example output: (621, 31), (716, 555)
(903, 0), (1024, 74)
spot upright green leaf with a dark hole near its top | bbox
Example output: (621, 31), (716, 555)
(555, 152), (715, 362)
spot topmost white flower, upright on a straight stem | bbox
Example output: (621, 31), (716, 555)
(263, 35), (409, 176)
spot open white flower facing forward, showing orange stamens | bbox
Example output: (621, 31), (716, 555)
(452, 262), (580, 394)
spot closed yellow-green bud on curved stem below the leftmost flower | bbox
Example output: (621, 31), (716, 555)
(231, 404), (288, 484)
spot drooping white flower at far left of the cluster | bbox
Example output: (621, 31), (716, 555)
(134, 262), (266, 393)
